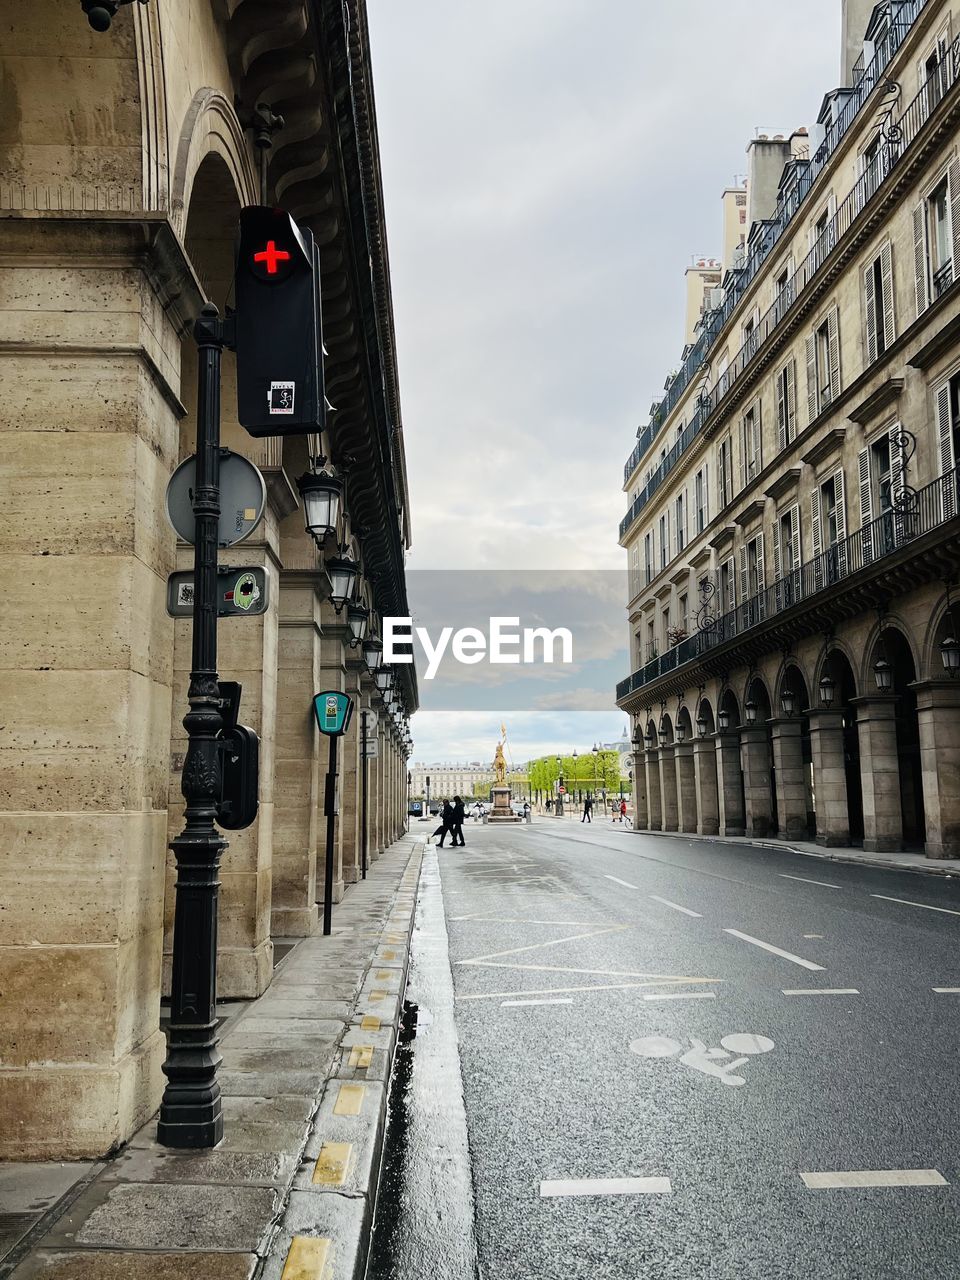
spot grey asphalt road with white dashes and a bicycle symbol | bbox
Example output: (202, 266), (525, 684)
(373, 819), (960, 1280)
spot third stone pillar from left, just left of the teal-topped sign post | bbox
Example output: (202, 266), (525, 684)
(271, 572), (325, 938)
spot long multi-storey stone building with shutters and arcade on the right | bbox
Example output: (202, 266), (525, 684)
(617, 0), (960, 858)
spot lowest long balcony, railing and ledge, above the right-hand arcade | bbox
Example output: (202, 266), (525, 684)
(617, 468), (960, 704)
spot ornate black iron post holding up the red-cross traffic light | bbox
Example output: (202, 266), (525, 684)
(161, 307), (227, 1148)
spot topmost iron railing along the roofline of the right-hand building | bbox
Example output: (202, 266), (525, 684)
(623, 0), (955, 484)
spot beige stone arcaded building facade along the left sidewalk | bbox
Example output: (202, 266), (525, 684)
(0, 0), (417, 1158)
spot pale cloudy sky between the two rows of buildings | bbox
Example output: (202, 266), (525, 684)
(369, 0), (841, 759)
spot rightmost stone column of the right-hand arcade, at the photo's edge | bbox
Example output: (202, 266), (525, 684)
(914, 680), (960, 858)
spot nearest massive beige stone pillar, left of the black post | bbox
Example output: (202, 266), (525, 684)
(0, 220), (202, 1160)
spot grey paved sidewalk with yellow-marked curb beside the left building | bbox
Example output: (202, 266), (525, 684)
(0, 832), (424, 1280)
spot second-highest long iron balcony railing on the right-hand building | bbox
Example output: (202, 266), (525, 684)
(620, 23), (960, 538)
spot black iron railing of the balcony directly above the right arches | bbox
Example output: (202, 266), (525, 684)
(617, 468), (960, 701)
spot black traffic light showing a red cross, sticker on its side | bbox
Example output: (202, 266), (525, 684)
(236, 205), (324, 436)
